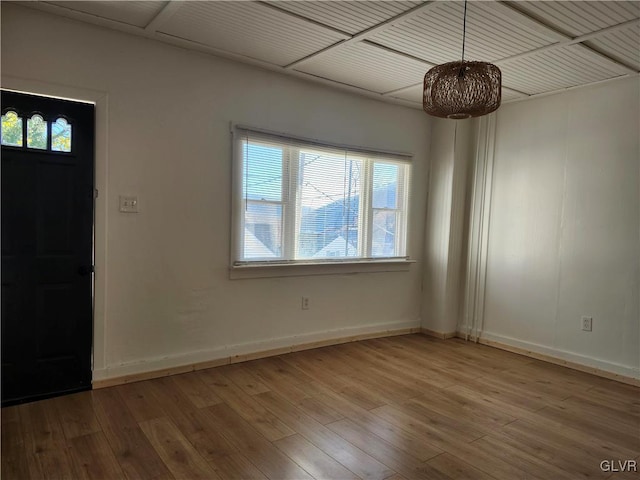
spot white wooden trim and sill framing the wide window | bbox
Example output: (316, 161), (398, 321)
(229, 122), (416, 279)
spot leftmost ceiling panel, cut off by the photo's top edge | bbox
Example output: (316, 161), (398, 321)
(45, 1), (167, 27)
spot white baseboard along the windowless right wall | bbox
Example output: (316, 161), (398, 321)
(468, 332), (640, 385)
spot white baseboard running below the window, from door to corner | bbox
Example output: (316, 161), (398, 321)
(93, 319), (420, 388)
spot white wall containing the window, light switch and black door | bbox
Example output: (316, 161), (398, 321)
(2, 2), (430, 378)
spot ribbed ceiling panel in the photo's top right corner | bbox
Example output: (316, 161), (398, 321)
(511, 1), (640, 37)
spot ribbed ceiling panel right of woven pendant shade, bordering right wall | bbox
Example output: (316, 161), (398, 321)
(499, 44), (628, 94)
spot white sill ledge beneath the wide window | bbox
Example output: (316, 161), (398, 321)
(229, 258), (416, 280)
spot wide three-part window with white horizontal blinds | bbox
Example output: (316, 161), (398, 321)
(233, 128), (411, 266)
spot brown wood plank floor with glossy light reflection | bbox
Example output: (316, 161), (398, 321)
(1, 334), (640, 480)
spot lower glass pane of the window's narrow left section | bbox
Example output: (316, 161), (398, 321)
(244, 201), (282, 260)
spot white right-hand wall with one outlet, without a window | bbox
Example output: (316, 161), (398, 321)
(482, 77), (640, 377)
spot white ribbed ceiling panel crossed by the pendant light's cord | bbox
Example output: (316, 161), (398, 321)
(370, 2), (559, 63)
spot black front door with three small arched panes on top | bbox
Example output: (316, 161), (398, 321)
(0, 91), (94, 406)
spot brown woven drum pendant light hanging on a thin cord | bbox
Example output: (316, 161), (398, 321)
(422, 0), (502, 120)
